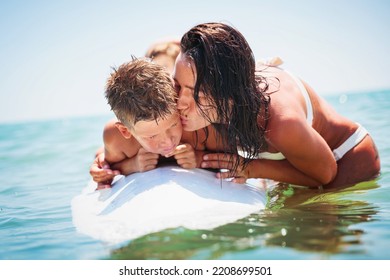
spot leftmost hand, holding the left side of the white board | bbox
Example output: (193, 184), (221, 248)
(89, 153), (120, 190)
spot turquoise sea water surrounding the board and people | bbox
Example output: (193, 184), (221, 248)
(0, 91), (390, 260)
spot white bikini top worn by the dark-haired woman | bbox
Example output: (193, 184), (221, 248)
(237, 57), (313, 160)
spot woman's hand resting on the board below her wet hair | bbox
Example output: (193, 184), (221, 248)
(201, 153), (249, 184)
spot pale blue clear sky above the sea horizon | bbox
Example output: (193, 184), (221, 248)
(0, 0), (390, 122)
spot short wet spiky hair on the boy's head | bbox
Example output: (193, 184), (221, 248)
(105, 57), (177, 129)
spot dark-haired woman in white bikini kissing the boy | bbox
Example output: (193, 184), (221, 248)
(173, 23), (380, 187)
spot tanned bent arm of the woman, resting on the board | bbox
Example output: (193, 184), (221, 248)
(202, 118), (337, 187)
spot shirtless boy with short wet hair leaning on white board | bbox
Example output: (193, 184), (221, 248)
(91, 58), (205, 189)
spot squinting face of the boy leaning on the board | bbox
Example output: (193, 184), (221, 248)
(130, 113), (183, 156)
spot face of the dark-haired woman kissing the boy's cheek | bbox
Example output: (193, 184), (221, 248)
(172, 53), (216, 131)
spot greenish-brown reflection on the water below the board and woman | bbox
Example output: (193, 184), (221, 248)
(110, 181), (379, 259)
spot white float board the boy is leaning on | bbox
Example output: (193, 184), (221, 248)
(71, 165), (269, 244)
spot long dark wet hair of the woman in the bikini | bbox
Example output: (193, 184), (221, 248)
(181, 23), (270, 169)
